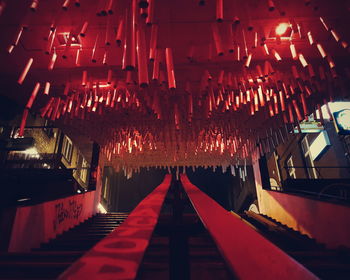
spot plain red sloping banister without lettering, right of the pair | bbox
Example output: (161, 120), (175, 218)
(181, 174), (318, 280)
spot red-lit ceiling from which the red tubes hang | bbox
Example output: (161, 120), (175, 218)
(0, 0), (350, 168)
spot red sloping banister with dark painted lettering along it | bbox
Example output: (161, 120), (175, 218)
(59, 175), (171, 280)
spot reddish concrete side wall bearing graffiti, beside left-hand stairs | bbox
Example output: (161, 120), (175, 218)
(8, 191), (96, 252)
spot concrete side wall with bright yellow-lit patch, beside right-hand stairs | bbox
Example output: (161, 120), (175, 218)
(253, 163), (350, 248)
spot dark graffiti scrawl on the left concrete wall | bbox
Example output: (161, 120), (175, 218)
(53, 199), (83, 230)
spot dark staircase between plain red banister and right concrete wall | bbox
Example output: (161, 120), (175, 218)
(242, 211), (350, 280)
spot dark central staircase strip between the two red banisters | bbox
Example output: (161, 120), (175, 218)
(137, 200), (234, 280)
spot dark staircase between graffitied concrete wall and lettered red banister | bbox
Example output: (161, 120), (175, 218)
(0, 213), (128, 279)
